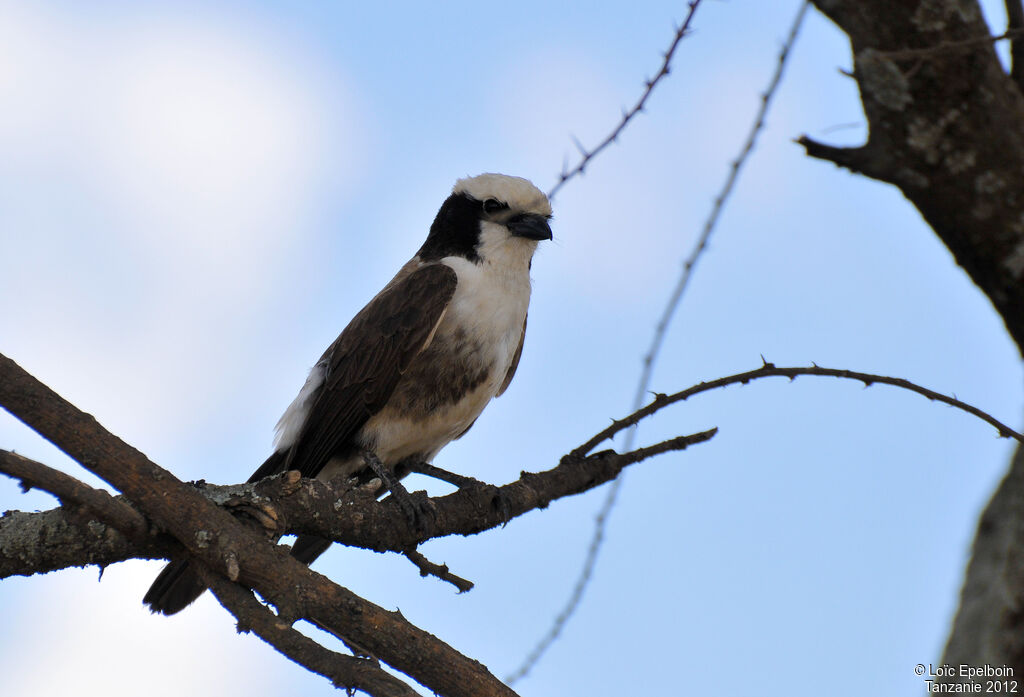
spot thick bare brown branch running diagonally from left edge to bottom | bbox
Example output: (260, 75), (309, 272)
(0, 355), (515, 697)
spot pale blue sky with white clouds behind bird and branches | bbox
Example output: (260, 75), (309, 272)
(0, 0), (1024, 697)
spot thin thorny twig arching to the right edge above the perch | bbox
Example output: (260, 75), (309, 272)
(571, 362), (1024, 456)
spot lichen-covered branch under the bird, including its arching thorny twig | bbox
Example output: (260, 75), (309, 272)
(0, 356), (1011, 577)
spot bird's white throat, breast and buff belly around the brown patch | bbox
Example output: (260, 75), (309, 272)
(352, 222), (537, 471)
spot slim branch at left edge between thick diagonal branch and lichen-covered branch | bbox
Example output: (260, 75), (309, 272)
(0, 450), (150, 540)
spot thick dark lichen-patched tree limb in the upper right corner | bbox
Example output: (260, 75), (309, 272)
(801, 0), (1024, 352)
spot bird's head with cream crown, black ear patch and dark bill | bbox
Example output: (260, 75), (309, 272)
(419, 174), (551, 264)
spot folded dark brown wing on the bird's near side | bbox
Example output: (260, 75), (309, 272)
(284, 264), (458, 477)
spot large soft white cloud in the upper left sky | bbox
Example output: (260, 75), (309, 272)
(0, 4), (367, 446)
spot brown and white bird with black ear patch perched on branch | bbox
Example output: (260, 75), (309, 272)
(142, 173), (552, 615)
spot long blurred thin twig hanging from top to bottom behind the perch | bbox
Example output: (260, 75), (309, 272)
(505, 0), (810, 685)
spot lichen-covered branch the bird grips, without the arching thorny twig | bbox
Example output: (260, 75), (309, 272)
(0, 430), (715, 584)
